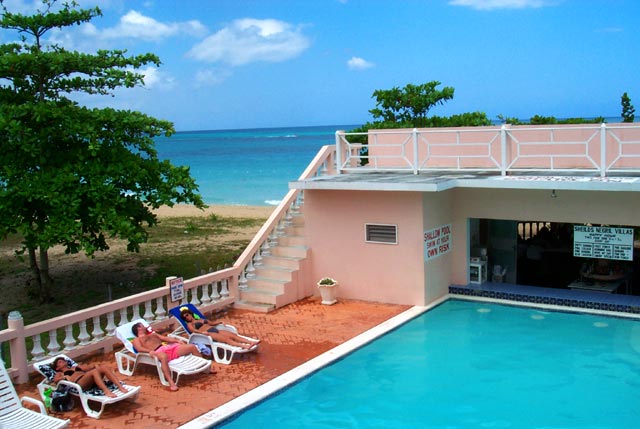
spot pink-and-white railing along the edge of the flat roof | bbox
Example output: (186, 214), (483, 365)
(336, 123), (640, 177)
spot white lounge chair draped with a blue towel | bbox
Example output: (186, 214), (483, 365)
(169, 304), (258, 365)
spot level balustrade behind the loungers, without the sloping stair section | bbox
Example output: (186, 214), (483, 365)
(0, 268), (238, 383)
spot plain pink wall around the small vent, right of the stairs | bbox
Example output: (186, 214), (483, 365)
(304, 190), (425, 305)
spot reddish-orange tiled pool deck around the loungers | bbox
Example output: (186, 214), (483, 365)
(16, 297), (410, 429)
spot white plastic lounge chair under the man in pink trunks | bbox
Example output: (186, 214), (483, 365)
(116, 319), (211, 386)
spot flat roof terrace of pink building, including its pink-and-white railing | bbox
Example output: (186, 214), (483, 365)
(289, 123), (640, 192)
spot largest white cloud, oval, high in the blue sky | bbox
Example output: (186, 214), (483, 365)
(188, 18), (310, 66)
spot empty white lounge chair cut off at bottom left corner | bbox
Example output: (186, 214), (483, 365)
(0, 359), (69, 429)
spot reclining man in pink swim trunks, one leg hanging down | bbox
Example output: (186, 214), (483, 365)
(131, 323), (202, 392)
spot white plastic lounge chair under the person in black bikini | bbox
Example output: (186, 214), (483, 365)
(34, 354), (140, 419)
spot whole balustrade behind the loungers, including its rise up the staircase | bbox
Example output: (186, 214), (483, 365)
(0, 142), (336, 383)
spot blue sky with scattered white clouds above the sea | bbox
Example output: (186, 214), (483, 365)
(0, 0), (640, 131)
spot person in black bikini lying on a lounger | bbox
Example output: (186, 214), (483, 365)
(51, 357), (128, 398)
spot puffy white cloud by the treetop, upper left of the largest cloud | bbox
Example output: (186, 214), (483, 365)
(99, 10), (207, 41)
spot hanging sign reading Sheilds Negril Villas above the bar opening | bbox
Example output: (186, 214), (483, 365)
(573, 225), (633, 261)
